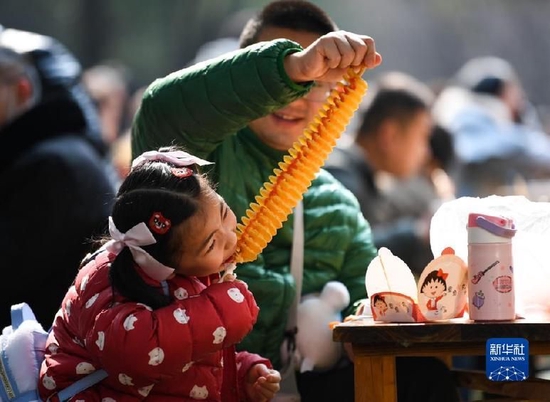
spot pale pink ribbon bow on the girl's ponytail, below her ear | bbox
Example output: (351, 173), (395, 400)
(105, 216), (174, 282)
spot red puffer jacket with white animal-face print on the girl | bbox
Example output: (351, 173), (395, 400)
(39, 252), (271, 402)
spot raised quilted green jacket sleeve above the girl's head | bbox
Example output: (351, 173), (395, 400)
(132, 39), (311, 158)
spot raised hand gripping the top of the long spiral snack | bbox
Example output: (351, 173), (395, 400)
(285, 31), (382, 82)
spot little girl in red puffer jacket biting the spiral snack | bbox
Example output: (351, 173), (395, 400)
(39, 149), (281, 402)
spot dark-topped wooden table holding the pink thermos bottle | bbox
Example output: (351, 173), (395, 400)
(333, 318), (550, 402)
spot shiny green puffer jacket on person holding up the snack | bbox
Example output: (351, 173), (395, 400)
(132, 40), (376, 367)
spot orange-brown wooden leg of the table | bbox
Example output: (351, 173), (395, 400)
(354, 353), (397, 402)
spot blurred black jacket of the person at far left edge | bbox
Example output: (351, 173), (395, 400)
(0, 29), (116, 329)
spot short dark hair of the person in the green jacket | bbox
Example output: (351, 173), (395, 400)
(239, 0), (338, 48)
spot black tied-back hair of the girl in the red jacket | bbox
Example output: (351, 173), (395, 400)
(109, 149), (212, 309)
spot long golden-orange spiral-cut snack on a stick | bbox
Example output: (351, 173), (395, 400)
(235, 69), (367, 263)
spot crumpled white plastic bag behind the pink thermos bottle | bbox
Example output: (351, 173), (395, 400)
(430, 195), (550, 318)
